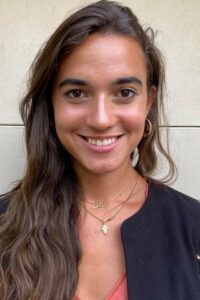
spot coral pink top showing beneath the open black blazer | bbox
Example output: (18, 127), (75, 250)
(74, 273), (128, 300)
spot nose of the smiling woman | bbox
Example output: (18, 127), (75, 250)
(87, 96), (115, 130)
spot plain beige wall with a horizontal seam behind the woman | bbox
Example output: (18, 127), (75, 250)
(0, 0), (200, 199)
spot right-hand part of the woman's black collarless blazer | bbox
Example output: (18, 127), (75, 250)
(121, 183), (200, 300)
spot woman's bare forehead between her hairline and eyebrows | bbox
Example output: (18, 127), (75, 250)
(54, 33), (147, 82)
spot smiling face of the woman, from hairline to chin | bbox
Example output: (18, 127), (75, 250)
(52, 33), (153, 174)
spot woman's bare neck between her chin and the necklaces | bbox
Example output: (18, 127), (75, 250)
(74, 164), (137, 205)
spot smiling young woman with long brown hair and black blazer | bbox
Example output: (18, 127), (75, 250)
(0, 0), (200, 300)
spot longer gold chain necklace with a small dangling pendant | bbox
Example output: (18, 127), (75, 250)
(83, 175), (139, 234)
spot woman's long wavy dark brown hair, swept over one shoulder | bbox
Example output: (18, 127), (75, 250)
(0, 0), (174, 300)
